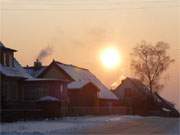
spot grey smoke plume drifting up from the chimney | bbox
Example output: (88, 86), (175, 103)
(37, 46), (53, 61)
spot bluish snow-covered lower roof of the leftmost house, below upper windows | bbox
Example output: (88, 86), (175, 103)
(0, 58), (32, 78)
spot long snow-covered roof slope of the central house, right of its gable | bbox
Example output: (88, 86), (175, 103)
(56, 62), (118, 100)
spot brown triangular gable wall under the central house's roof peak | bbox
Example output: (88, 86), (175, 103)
(38, 64), (72, 81)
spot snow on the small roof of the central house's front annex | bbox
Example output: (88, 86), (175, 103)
(68, 80), (89, 89)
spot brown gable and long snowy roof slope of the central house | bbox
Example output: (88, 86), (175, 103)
(38, 61), (118, 100)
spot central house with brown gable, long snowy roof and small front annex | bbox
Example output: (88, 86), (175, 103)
(26, 61), (118, 113)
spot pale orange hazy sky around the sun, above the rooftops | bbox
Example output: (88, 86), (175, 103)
(0, 0), (180, 108)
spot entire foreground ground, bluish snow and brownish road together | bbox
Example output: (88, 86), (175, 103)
(0, 116), (180, 135)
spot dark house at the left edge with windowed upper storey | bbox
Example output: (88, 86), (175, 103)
(0, 42), (32, 120)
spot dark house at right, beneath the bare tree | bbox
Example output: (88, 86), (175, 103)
(114, 77), (179, 116)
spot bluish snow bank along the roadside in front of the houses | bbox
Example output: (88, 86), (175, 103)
(0, 116), (141, 135)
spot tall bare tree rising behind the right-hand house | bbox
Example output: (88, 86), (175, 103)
(131, 41), (174, 93)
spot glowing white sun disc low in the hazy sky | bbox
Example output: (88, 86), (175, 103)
(100, 47), (121, 69)
